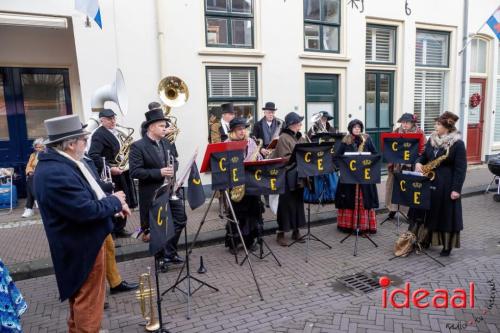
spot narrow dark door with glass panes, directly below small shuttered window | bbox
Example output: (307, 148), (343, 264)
(365, 71), (394, 151)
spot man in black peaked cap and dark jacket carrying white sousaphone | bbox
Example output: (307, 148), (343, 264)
(88, 109), (137, 238)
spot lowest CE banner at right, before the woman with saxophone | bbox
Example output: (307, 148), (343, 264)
(392, 172), (431, 210)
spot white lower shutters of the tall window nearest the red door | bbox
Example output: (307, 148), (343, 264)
(414, 71), (445, 134)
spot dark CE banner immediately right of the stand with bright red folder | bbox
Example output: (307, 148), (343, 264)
(245, 163), (286, 195)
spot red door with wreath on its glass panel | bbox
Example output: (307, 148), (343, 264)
(467, 78), (486, 163)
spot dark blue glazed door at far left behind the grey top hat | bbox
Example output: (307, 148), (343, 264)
(0, 67), (71, 196)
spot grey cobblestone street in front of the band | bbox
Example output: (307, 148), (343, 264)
(17, 194), (500, 332)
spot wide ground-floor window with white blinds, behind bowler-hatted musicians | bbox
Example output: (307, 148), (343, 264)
(207, 67), (257, 141)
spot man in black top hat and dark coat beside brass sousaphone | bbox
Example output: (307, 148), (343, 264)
(130, 102), (187, 264)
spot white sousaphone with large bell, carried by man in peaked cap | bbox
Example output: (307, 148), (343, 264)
(87, 69), (134, 170)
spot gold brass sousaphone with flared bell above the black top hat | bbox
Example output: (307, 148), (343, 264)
(158, 76), (189, 143)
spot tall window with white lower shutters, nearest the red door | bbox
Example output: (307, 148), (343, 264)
(414, 29), (450, 134)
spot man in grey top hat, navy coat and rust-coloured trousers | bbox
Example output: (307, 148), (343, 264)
(34, 115), (130, 332)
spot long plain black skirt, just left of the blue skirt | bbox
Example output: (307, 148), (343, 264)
(278, 188), (306, 232)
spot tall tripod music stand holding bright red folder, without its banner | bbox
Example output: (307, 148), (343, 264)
(172, 141), (264, 301)
